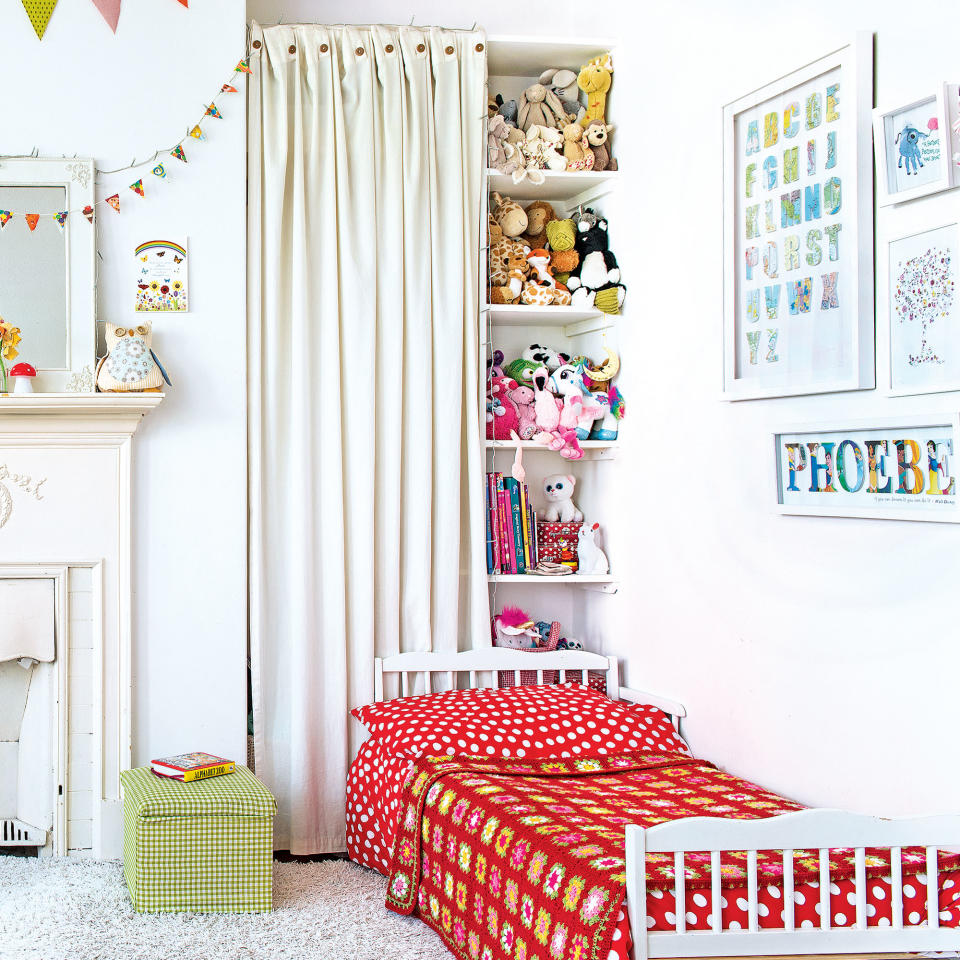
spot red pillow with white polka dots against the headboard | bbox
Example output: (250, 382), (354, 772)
(352, 683), (690, 757)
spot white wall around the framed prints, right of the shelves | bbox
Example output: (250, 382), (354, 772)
(253, 0), (960, 815)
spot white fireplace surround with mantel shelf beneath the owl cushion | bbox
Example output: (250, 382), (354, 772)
(0, 393), (164, 857)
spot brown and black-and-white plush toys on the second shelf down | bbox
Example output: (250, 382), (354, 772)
(488, 199), (627, 314)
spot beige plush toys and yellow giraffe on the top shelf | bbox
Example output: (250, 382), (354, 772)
(487, 53), (617, 183)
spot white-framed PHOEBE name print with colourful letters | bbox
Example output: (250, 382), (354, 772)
(773, 413), (960, 523)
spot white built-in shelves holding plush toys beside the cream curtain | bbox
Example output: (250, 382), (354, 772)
(478, 36), (627, 635)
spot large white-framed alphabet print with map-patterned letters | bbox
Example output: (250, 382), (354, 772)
(723, 34), (875, 400)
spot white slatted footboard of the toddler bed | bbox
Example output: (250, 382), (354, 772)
(626, 810), (960, 960)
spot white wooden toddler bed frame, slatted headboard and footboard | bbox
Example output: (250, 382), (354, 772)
(375, 648), (960, 960)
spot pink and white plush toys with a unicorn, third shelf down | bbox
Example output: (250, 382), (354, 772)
(486, 343), (626, 454)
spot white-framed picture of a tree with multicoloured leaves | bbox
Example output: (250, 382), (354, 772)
(877, 196), (960, 397)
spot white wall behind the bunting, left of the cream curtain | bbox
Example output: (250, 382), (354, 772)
(0, 0), (246, 764)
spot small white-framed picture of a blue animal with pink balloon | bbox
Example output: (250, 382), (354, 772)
(873, 83), (956, 207)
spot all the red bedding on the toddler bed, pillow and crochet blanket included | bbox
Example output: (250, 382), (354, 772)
(346, 684), (960, 960)
